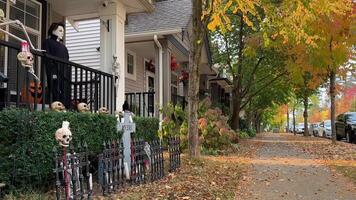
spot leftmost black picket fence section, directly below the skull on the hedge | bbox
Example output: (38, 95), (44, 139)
(53, 144), (93, 200)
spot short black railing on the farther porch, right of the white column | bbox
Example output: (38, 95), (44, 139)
(125, 92), (155, 117)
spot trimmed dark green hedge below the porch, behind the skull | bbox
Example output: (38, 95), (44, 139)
(0, 109), (158, 189)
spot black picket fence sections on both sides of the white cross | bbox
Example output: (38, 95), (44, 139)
(93, 138), (171, 196)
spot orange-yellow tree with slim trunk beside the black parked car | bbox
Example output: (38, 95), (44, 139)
(265, 0), (356, 143)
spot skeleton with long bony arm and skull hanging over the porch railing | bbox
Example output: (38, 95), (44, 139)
(0, 9), (43, 81)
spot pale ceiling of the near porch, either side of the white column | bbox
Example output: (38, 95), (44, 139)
(47, 0), (151, 16)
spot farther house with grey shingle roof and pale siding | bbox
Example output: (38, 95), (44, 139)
(67, 0), (215, 116)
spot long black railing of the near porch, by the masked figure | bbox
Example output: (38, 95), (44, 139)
(0, 40), (116, 113)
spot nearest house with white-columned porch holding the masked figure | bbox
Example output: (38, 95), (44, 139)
(0, 0), (154, 112)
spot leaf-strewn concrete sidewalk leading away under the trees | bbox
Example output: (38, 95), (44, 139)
(244, 133), (356, 200)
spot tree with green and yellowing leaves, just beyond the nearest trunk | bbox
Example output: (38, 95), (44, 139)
(211, 4), (286, 130)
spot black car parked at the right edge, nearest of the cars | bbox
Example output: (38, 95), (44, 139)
(335, 112), (356, 143)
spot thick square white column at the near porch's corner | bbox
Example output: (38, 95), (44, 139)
(99, 1), (126, 111)
